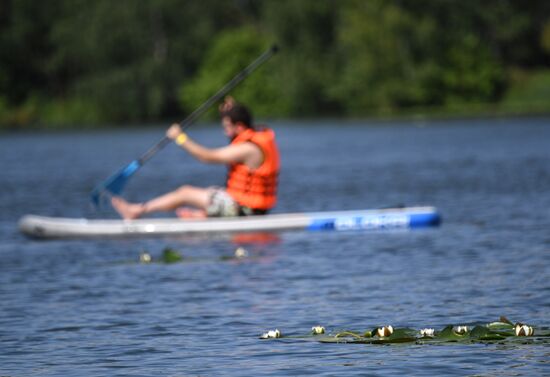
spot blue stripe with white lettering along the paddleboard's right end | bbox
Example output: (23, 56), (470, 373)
(307, 212), (440, 231)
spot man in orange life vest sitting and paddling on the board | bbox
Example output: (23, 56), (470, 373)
(111, 97), (279, 219)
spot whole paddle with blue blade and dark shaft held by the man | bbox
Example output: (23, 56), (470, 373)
(90, 45), (279, 207)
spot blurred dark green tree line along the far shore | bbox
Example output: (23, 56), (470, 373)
(0, 0), (550, 128)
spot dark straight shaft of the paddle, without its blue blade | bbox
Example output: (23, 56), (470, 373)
(137, 45), (278, 166)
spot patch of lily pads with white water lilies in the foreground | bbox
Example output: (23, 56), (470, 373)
(260, 317), (550, 344)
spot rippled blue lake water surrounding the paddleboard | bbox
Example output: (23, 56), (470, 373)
(0, 118), (550, 376)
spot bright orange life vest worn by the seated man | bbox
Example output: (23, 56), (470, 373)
(226, 128), (279, 211)
